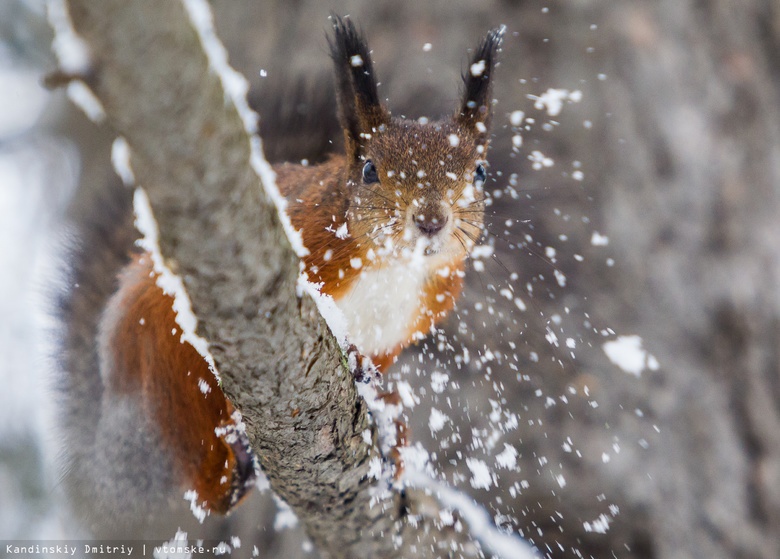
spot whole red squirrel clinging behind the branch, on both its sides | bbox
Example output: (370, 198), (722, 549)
(60, 17), (501, 526)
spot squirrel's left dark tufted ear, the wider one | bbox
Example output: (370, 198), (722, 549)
(328, 14), (390, 158)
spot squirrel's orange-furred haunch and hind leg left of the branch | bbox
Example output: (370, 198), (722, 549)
(101, 255), (254, 513)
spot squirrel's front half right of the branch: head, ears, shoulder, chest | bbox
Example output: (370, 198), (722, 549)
(278, 16), (502, 371)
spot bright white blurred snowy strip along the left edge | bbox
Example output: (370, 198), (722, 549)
(0, 2), (78, 539)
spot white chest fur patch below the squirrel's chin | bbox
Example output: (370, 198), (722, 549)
(336, 260), (432, 355)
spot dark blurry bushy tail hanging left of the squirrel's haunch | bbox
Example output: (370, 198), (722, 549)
(53, 177), (137, 524)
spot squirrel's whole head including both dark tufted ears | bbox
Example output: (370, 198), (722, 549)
(330, 16), (503, 259)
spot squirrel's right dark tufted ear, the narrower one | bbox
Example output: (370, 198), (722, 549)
(455, 26), (505, 143)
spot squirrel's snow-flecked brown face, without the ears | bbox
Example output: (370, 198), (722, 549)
(347, 118), (486, 260)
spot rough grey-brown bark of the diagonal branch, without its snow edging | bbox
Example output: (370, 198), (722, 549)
(68, 0), (482, 557)
